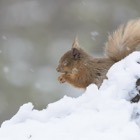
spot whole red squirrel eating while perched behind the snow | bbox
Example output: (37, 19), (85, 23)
(57, 20), (140, 88)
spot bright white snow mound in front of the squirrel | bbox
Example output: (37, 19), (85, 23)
(0, 52), (140, 140)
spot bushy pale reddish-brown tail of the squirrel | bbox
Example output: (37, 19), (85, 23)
(105, 19), (140, 62)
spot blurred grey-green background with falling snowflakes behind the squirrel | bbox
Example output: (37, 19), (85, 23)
(0, 0), (140, 123)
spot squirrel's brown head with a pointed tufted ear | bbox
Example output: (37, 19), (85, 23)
(56, 38), (89, 74)
